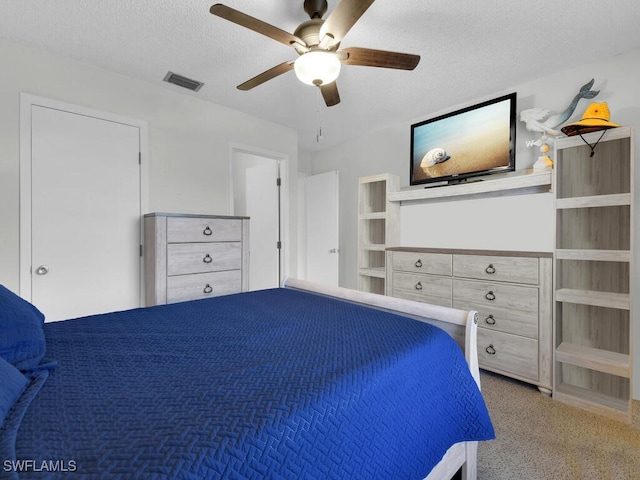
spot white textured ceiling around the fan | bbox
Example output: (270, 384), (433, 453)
(0, 0), (640, 151)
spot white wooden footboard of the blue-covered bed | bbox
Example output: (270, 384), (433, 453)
(282, 278), (480, 480)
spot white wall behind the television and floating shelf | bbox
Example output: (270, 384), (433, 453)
(311, 50), (640, 398)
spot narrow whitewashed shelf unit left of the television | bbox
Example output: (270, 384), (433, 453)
(358, 173), (400, 295)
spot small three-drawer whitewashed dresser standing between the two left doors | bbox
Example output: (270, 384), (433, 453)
(144, 213), (249, 306)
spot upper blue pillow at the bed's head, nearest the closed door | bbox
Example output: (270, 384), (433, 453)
(0, 285), (46, 370)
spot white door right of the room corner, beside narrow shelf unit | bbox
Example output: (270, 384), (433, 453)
(305, 170), (340, 286)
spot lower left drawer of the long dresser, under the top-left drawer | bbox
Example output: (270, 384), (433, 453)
(392, 272), (452, 307)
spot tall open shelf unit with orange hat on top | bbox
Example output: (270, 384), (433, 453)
(553, 127), (634, 423)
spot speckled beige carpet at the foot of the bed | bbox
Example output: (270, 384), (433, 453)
(478, 371), (640, 480)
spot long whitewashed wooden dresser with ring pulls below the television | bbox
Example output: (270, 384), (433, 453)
(386, 247), (553, 395)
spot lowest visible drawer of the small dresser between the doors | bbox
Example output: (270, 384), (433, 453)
(167, 270), (242, 303)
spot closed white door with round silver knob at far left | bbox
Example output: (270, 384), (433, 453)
(31, 105), (141, 321)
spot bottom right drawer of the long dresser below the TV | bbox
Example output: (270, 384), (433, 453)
(478, 328), (538, 382)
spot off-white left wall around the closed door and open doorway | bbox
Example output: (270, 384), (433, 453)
(0, 40), (298, 291)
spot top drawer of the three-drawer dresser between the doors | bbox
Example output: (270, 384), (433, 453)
(167, 217), (242, 243)
